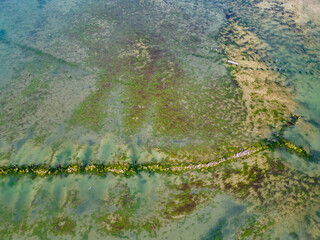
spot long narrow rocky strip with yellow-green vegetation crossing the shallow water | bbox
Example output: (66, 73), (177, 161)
(0, 140), (311, 177)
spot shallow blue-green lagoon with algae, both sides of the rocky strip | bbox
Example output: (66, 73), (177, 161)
(0, 0), (320, 239)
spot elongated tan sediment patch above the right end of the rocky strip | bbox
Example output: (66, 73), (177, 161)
(221, 22), (295, 136)
